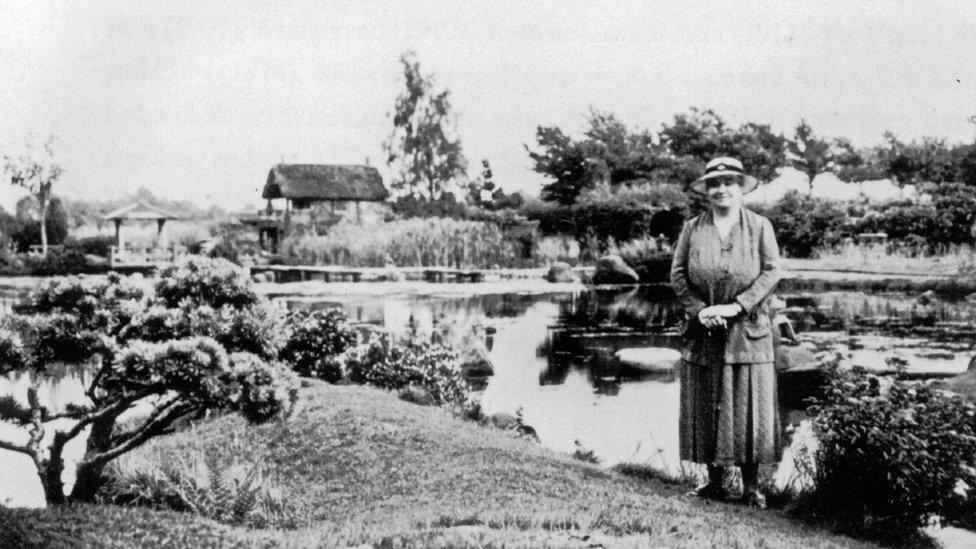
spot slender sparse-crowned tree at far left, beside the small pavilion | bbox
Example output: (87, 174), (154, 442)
(3, 135), (63, 255)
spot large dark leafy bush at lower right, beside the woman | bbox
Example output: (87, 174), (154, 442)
(806, 371), (976, 536)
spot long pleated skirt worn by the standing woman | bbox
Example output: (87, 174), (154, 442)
(679, 361), (781, 465)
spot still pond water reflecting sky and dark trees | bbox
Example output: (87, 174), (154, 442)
(0, 286), (976, 505)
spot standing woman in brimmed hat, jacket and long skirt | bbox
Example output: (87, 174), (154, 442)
(671, 158), (780, 507)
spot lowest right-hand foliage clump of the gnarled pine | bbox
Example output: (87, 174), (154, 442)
(230, 353), (298, 423)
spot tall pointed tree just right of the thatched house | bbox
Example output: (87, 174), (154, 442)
(383, 52), (467, 200)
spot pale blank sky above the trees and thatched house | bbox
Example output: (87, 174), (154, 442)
(0, 0), (976, 211)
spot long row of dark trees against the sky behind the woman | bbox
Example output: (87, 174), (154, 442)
(526, 108), (976, 205)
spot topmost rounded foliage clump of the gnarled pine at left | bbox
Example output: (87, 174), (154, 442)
(156, 257), (259, 309)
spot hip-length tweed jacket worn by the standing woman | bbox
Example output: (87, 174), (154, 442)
(671, 208), (780, 364)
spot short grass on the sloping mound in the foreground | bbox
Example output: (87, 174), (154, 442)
(0, 383), (866, 547)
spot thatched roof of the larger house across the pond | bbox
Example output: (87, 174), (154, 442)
(261, 164), (390, 202)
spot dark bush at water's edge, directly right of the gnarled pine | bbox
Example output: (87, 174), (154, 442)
(278, 309), (356, 383)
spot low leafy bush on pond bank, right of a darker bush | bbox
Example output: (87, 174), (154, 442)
(346, 334), (468, 404)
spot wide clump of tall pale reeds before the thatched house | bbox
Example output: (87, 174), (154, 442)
(285, 218), (519, 268)
